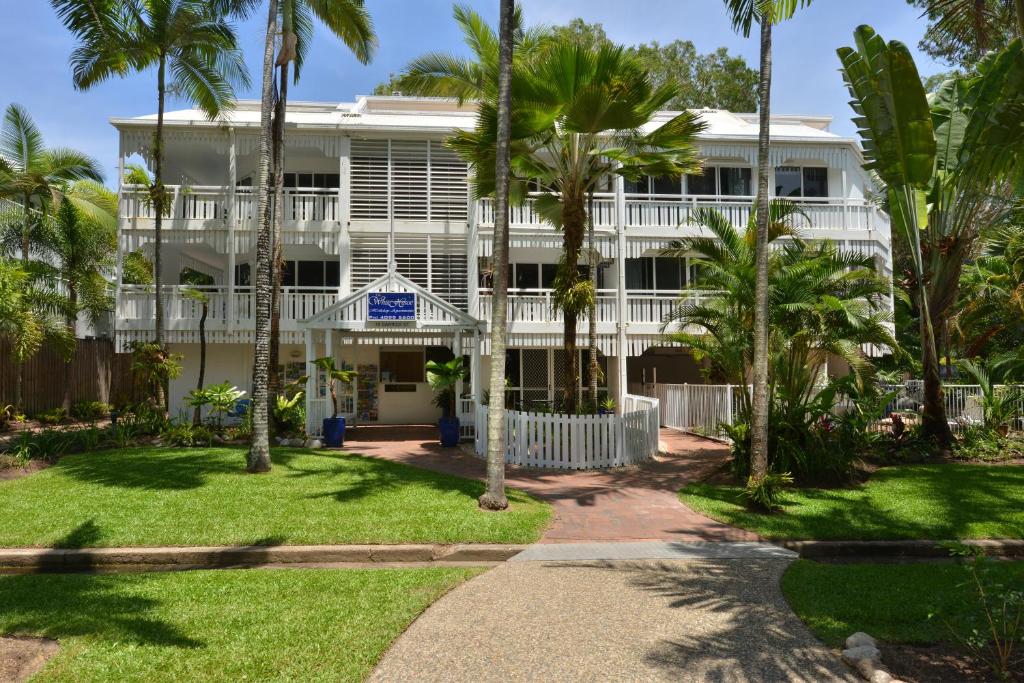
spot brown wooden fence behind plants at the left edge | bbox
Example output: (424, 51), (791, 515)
(0, 339), (139, 416)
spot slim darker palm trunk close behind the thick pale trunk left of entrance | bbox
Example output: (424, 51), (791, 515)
(267, 62), (289, 416)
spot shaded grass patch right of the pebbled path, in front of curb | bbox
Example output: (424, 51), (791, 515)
(782, 560), (1024, 647)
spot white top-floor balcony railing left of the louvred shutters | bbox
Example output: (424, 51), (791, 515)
(121, 185), (340, 228)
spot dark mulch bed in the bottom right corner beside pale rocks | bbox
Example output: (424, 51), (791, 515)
(880, 643), (1024, 683)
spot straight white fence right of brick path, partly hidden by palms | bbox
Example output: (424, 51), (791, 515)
(630, 380), (1024, 439)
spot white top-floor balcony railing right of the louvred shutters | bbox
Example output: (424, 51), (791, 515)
(477, 194), (889, 234)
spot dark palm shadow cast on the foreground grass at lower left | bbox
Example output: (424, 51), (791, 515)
(0, 573), (205, 648)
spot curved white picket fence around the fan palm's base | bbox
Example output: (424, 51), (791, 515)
(475, 395), (658, 470)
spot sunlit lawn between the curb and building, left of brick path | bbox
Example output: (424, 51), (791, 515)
(0, 447), (551, 548)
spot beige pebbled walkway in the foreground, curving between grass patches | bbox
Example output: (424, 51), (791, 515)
(370, 558), (857, 683)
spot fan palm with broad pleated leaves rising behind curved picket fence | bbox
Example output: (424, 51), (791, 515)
(449, 44), (705, 414)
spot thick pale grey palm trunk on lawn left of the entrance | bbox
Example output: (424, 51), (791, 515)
(247, 0), (278, 472)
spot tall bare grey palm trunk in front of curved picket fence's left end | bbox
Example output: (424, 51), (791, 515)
(476, 0), (515, 510)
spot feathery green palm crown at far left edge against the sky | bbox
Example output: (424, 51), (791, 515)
(0, 104), (104, 261)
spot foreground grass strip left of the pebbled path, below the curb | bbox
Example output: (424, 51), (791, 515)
(0, 568), (476, 683)
